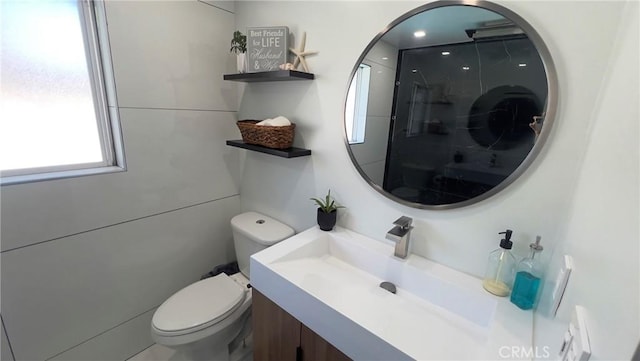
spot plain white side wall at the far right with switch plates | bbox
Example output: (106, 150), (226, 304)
(535, 2), (640, 360)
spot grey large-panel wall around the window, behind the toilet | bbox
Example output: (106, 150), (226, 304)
(1, 1), (240, 360)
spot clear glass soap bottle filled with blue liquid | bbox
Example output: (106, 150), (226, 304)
(511, 236), (543, 310)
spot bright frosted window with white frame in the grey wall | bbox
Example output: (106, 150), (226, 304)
(0, 0), (124, 184)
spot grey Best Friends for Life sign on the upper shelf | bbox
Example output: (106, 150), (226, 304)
(247, 26), (289, 73)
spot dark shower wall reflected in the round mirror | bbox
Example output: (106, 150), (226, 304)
(383, 32), (547, 204)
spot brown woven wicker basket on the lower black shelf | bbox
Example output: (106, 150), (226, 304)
(237, 120), (296, 149)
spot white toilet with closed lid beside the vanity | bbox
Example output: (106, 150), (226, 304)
(151, 212), (295, 361)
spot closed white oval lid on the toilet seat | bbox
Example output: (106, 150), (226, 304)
(152, 273), (245, 332)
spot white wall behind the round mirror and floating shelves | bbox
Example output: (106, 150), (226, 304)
(237, 1), (622, 284)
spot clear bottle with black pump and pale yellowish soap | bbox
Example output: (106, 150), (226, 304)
(482, 229), (516, 297)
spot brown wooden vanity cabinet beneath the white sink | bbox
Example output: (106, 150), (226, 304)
(252, 288), (350, 361)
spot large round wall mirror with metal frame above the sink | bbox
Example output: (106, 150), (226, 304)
(345, 1), (557, 209)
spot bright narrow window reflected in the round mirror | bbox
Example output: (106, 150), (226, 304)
(345, 64), (371, 144)
